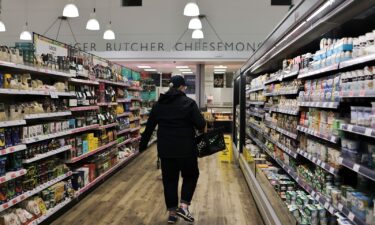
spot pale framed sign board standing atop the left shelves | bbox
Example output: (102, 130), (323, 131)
(33, 33), (68, 56)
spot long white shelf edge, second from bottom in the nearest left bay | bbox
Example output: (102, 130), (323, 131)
(0, 171), (72, 212)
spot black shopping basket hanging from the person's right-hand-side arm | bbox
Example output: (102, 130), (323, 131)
(195, 129), (226, 158)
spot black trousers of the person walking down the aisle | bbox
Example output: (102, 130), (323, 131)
(161, 157), (203, 211)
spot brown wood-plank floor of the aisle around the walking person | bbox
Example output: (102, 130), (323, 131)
(52, 145), (263, 225)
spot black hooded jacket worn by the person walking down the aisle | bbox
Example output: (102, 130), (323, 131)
(139, 90), (206, 158)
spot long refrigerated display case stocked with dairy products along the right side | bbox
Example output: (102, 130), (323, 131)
(234, 1), (375, 225)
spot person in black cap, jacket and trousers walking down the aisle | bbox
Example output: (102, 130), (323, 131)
(139, 76), (206, 224)
